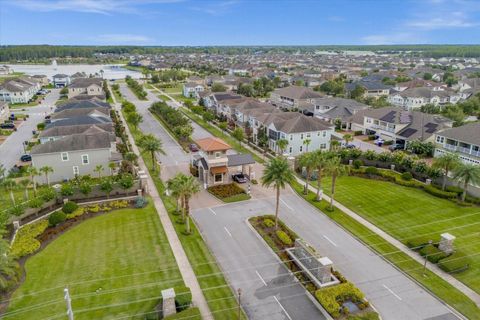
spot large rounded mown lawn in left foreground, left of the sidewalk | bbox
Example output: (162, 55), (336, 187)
(3, 204), (183, 320)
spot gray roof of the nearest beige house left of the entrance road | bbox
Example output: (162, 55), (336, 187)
(31, 132), (111, 155)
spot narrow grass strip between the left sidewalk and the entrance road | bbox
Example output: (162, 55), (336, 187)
(122, 109), (245, 320)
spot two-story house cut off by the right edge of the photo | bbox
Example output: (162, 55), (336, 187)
(434, 122), (480, 165)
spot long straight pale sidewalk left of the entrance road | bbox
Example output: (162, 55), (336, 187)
(110, 84), (213, 320)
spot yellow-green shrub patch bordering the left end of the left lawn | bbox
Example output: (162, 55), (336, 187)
(11, 220), (48, 258)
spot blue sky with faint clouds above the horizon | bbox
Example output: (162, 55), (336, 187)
(0, 0), (480, 46)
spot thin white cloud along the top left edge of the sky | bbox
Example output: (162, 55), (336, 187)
(7, 0), (182, 15)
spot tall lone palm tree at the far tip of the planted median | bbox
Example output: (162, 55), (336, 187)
(262, 157), (295, 229)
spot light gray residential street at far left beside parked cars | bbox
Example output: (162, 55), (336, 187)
(0, 89), (60, 169)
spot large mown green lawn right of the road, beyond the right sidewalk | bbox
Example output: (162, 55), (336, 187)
(318, 176), (480, 292)
